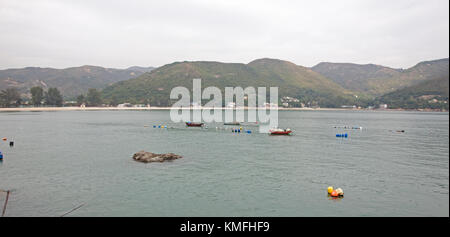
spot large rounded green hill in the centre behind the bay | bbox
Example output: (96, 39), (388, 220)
(103, 59), (354, 107)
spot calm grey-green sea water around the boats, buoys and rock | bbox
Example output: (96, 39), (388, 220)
(0, 111), (449, 216)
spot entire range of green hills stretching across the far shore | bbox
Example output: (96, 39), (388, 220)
(0, 58), (449, 110)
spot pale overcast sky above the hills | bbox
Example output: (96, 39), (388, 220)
(0, 0), (449, 69)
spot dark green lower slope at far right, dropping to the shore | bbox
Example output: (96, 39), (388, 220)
(376, 76), (449, 110)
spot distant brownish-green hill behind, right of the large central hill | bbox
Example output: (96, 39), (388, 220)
(312, 58), (449, 96)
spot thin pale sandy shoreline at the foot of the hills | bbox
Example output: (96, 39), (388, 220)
(0, 106), (448, 112)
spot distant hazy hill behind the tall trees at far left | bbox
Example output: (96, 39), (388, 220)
(0, 66), (152, 98)
